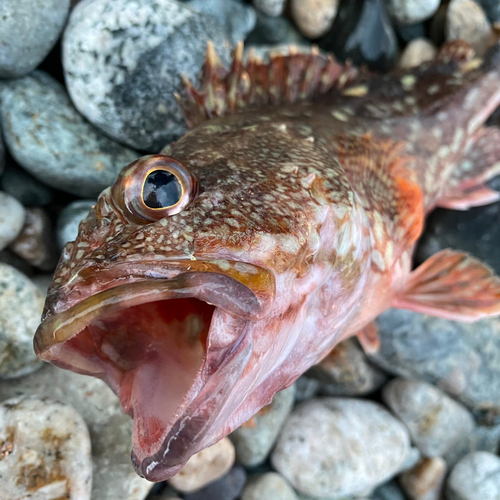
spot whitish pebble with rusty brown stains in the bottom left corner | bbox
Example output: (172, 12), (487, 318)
(0, 397), (92, 500)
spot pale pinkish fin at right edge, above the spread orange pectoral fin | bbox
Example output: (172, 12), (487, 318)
(438, 127), (500, 210)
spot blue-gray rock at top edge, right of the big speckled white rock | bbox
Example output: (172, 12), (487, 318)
(186, 0), (257, 44)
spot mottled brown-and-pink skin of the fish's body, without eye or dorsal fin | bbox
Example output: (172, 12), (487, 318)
(35, 44), (500, 481)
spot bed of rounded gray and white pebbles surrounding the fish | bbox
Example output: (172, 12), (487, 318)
(0, 0), (500, 500)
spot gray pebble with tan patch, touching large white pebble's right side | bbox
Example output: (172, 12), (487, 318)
(382, 378), (474, 457)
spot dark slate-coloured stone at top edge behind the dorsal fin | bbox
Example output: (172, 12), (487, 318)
(320, 0), (398, 71)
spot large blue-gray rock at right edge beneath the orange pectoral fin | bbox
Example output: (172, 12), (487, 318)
(371, 309), (500, 425)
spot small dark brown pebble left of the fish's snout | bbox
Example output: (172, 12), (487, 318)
(9, 208), (59, 271)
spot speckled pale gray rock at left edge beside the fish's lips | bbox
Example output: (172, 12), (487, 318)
(0, 264), (44, 379)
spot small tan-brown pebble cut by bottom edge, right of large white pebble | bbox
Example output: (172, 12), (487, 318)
(399, 457), (447, 500)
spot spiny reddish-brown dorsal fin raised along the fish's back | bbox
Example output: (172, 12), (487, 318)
(176, 42), (359, 127)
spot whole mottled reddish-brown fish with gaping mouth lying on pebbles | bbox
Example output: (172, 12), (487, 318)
(34, 41), (500, 481)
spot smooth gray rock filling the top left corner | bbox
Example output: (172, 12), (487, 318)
(0, 0), (70, 78)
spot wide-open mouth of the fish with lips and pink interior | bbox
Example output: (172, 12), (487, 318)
(34, 261), (274, 476)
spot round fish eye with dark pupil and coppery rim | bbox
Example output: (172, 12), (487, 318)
(111, 155), (198, 224)
